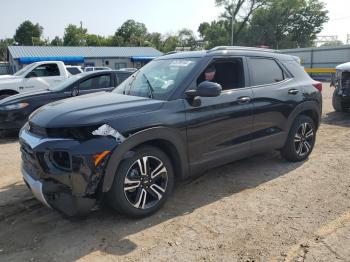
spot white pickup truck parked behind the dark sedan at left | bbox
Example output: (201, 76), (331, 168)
(0, 61), (71, 100)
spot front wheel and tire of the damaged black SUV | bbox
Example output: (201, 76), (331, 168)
(107, 146), (174, 218)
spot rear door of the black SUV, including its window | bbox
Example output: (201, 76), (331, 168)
(248, 57), (303, 151)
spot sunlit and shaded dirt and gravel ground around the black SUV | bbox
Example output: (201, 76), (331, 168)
(0, 84), (350, 261)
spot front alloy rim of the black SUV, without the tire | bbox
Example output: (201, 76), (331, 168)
(124, 156), (168, 209)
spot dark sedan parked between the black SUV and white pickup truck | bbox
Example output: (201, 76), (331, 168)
(0, 71), (131, 131)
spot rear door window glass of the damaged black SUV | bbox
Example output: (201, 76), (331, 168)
(250, 58), (284, 86)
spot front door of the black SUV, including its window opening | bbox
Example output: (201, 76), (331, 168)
(185, 57), (253, 172)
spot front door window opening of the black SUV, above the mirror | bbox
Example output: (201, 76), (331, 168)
(197, 58), (245, 90)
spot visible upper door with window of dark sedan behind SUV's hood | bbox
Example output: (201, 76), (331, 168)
(79, 73), (114, 95)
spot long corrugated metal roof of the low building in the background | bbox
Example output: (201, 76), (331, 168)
(8, 46), (163, 59)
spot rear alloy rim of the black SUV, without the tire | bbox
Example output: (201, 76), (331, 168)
(294, 122), (315, 157)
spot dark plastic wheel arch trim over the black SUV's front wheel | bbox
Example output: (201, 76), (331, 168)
(102, 127), (189, 192)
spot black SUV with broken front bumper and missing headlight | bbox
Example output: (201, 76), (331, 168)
(20, 47), (322, 217)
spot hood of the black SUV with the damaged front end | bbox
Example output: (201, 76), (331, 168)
(29, 92), (164, 128)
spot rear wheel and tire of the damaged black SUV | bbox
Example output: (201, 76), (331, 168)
(281, 115), (316, 162)
